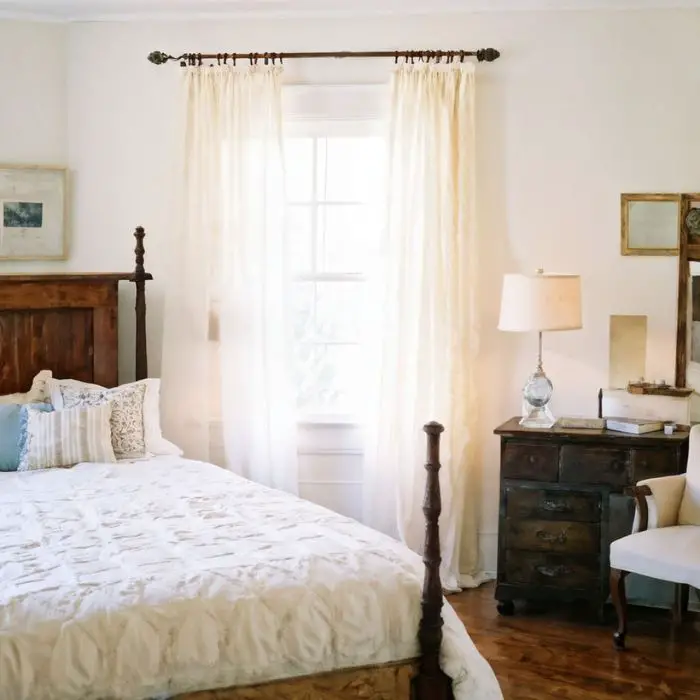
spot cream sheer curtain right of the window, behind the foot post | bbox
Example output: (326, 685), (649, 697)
(363, 64), (483, 590)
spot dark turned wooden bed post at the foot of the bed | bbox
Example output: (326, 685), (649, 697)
(412, 422), (453, 700)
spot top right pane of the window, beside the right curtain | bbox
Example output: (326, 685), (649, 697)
(316, 137), (384, 202)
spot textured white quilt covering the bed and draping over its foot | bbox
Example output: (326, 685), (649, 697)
(0, 457), (502, 700)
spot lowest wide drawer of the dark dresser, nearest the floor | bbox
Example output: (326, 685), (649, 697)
(505, 550), (600, 589)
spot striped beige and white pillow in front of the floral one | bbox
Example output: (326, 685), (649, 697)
(17, 403), (117, 472)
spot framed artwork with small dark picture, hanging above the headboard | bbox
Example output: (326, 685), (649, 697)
(0, 165), (67, 260)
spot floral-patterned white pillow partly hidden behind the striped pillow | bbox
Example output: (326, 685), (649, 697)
(60, 384), (146, 459)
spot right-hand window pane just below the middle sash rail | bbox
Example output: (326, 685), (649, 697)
(314, 282), (365, 343)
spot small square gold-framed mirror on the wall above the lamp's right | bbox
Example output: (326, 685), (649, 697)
(621, 194), (681, 255)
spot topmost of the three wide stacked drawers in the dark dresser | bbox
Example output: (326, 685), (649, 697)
(506, 486), (600, 523)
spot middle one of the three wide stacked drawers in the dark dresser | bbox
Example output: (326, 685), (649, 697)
(506, 518), (600, 554)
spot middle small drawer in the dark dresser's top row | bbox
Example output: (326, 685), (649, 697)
(561, 445), (631, 486)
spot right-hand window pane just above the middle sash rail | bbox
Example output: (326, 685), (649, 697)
(316, 204), (378, 273)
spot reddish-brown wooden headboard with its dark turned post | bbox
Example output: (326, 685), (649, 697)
(0, 227), (152, 395)
